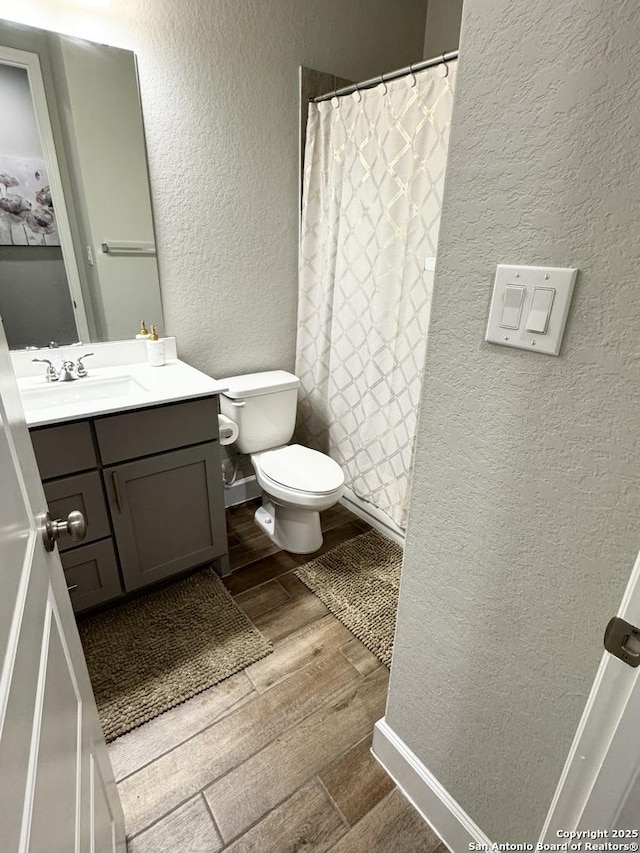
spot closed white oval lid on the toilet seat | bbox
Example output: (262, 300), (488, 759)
(260, 444), (344, 495)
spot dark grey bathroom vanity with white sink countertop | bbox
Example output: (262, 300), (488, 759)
(18, 345), (228, 612)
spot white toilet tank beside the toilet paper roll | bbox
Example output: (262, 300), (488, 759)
(220, 370), (300, 453)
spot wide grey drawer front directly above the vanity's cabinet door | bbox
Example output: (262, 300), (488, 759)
(95, 397), (218, 464)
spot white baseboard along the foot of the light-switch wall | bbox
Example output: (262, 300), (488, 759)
(371, 718), (493, 853)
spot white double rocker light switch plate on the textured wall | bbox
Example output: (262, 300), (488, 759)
(485, 264), (578, 355)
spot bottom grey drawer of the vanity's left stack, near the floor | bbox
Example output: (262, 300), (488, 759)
(60, 539), (122, 613)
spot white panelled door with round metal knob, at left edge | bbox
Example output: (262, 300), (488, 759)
(0, 323), (126, 853)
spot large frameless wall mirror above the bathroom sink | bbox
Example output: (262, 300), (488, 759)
(0, 21), (163, 349)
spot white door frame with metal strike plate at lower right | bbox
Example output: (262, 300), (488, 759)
(541, 554), (640, 836)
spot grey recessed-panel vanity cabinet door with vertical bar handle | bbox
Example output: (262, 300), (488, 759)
(104, 442), (227, 590)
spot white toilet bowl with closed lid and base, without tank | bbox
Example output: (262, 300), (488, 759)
(251, 444), (344, 554)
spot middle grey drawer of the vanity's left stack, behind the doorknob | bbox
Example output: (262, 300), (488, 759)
(44, 471), (111, 552)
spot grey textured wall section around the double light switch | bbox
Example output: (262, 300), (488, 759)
(387, 0), (640, 841)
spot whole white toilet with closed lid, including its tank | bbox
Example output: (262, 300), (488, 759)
(220, 370), (344, 554)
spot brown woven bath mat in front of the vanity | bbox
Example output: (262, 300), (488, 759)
(78, 568), (273, 742)
